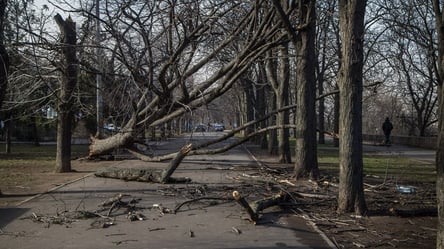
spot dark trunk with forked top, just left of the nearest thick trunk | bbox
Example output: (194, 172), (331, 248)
(294, 0), (319, 179)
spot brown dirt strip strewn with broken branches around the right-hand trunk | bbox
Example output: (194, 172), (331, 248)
(249, 148), (437, 249)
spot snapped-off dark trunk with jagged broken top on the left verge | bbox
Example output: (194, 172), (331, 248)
(54, 14), (78, 173)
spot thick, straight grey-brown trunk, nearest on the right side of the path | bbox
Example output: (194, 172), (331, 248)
(338, 0), (367, 215)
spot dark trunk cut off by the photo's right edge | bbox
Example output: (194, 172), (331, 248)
(433, 0), (444, 249)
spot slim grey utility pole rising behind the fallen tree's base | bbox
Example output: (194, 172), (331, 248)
(96, 0), (103, 138)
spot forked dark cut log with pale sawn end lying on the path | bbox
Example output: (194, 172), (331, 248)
(233, 191), (287, 225)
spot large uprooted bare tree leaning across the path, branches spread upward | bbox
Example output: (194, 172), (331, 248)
(85, 1), (286, 160)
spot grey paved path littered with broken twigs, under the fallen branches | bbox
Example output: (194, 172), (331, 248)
(0, 137), (332, 249)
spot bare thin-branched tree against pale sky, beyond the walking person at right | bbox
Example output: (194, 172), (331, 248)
(381, 1), (437, 136)
